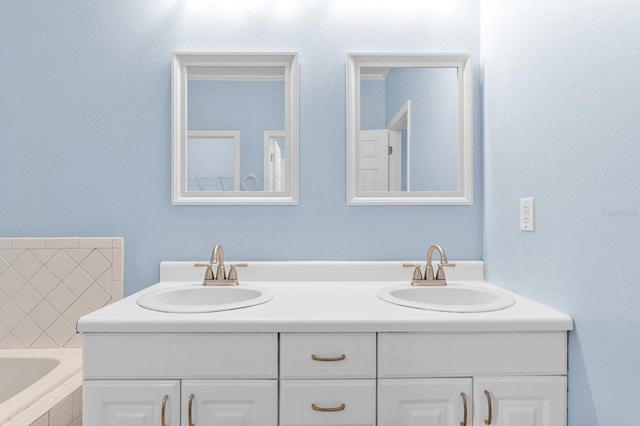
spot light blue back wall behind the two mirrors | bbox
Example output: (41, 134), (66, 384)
(0, 0), (483, 294)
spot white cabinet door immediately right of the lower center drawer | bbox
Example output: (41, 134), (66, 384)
(378, 378), (472, 426)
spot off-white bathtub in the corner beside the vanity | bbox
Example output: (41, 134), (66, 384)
(0, 348), (82, 425)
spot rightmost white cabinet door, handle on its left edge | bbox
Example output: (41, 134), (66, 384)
(473, 376), (567, 426)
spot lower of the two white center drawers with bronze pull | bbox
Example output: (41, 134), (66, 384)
(280, 379), (376, 426)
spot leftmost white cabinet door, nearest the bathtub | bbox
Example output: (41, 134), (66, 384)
(82, 380), (180, 426)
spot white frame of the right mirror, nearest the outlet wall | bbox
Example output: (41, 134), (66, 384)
(347, 53), (473, 205)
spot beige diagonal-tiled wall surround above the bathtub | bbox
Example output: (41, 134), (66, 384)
(0, 238), (124, 349)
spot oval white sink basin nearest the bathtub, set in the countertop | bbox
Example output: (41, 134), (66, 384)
(137, 285), (274, 313)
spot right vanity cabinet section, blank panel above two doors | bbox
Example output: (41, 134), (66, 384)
(378, 332), (567, 426)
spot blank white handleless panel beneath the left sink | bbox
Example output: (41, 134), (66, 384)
(83, 333), (278, 379)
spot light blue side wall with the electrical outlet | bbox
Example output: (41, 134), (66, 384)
(482, 0), (640, 426)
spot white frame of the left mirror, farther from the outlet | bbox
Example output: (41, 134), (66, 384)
(171, 52), (299, 205)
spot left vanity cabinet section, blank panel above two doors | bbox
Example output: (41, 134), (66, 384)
(83, 333), (278, 426)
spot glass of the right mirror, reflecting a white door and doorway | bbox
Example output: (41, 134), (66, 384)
(358, 67), (458, 191)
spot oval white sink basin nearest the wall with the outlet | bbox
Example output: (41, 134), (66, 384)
(378, 284), (516, 312)
